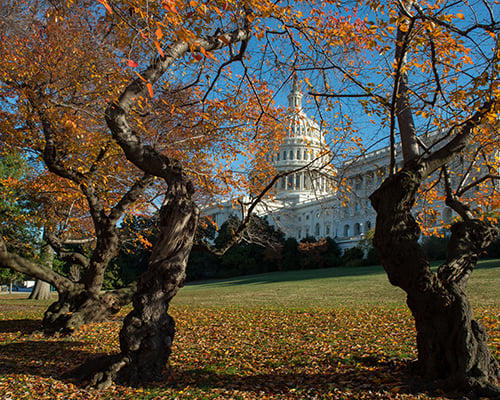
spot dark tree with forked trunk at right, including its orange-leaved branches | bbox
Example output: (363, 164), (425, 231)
(348, 1), (500, 397)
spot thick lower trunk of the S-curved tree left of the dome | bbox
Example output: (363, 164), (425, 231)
(74, 178), (199, 389)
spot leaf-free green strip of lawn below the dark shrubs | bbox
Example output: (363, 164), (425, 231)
(173, 260), (500, 308)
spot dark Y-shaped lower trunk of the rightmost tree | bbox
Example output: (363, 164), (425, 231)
(370, 166), (500, 397)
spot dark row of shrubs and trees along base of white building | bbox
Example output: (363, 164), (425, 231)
(76, 216), (500, 289)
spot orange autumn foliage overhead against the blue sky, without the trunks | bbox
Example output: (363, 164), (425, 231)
(0, 0), (498, 242)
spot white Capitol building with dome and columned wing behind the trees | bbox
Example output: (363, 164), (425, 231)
(202, 83), (464, 249)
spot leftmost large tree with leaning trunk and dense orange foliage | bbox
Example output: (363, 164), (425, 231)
(0, 1), (160, 333)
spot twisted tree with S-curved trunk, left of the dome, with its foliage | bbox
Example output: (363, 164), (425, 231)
(55, 1), (352, 388)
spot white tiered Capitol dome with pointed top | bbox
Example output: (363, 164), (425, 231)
(271, 80), (333, 199)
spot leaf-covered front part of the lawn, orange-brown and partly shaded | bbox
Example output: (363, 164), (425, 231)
(0, 306), (500, 400)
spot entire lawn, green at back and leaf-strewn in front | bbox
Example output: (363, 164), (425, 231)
(0, 260), (500, 400)
